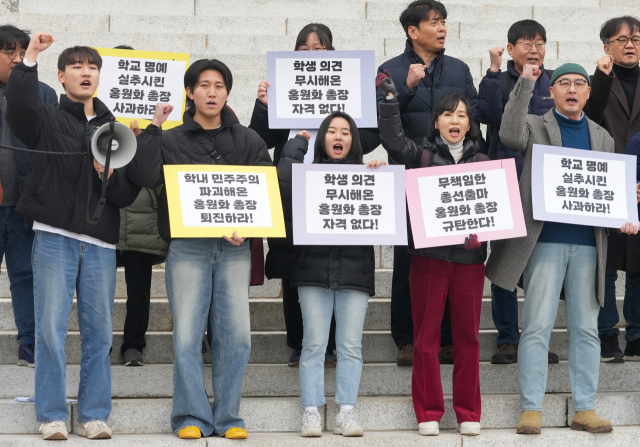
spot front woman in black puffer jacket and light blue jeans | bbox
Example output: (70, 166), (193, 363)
(278, 112), (386, 436)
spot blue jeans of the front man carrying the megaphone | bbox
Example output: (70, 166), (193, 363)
(32, 231), (116, 423)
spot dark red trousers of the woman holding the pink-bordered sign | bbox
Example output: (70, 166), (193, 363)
(409, 256), (484, 423)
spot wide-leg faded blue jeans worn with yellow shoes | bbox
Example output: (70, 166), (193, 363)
(165, 238), (251, 436)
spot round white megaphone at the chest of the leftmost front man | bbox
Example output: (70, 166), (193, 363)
(91, 121), (138, 169)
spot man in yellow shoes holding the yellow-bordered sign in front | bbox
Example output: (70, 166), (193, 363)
(128, 59), (272, 439)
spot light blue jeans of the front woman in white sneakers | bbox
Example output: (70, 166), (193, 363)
(298, 287), (369, 407)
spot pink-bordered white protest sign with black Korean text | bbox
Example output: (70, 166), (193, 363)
(406, 159), (527, 248)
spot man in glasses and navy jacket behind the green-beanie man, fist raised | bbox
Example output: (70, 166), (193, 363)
(478, 20), (558, 364)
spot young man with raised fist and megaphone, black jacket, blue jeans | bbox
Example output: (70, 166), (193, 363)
(5, 32), (140, 439)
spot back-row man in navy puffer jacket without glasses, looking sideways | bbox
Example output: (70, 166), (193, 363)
(377, 0), (478, 366)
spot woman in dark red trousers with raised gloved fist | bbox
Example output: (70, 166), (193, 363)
(378, 74), (489, 435)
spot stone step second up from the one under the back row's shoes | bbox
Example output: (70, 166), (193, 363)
(0, 298), (625, 332)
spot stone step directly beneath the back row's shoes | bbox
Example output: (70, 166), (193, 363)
(0, 361), (640, 400)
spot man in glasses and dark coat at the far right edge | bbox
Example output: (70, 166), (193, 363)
(585, 16), (640, 363)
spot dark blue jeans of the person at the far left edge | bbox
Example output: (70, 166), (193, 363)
(0, 206), (36, 345)
